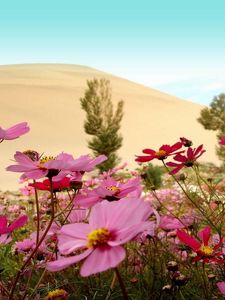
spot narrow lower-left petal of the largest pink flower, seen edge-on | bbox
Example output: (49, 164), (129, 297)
(46, 249), (93, 272)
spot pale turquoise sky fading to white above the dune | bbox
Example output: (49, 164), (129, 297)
(0, 0), (225, 105)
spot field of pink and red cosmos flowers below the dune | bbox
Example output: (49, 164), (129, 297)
(0, 122), (225, 300)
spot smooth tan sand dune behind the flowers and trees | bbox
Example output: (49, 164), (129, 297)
(0, 64), (218, 190)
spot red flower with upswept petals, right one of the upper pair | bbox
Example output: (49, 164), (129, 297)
(166, 145), (205, 174)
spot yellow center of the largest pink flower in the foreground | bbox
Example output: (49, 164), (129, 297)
(87, 228), (110, 248)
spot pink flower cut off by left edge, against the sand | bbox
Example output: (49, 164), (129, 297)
(0, 122), (30, 142)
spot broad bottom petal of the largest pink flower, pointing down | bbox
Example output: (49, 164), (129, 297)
(80, 246), (126, 277)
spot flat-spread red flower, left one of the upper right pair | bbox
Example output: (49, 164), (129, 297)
(135, 142), (184, 162)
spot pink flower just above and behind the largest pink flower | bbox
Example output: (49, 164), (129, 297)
(74, 177), (141, 208)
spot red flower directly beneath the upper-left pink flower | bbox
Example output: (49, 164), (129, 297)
(29, 177), (70, 191)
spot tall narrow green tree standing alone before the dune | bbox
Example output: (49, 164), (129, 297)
(80, 78), (124, 172)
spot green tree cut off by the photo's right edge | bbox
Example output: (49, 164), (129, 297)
(197, 94), (225, 161)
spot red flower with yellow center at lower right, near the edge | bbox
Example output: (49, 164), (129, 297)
(177, 226), (225, 263)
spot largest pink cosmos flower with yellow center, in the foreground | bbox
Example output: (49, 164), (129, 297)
(47, 199), (152, 276)
